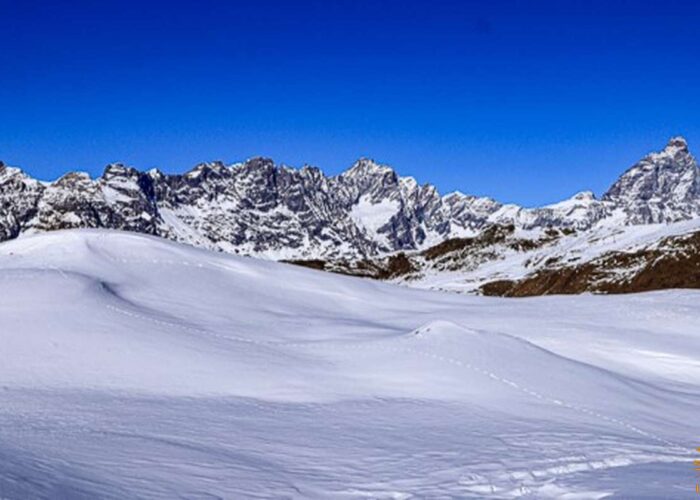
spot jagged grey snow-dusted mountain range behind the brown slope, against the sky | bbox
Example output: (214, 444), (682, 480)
(0, 138), (700, 260)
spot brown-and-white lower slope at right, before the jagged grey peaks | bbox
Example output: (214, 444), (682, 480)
(374, 218), (700, 296)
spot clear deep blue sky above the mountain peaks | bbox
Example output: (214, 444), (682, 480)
(0, 0), (700, 205)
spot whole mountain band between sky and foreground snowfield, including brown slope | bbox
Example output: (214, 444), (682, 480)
(0, 137), (700, 296)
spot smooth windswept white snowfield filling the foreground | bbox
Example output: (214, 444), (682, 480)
(0, 231), (700, 499)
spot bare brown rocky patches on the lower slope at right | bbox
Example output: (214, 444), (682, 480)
(302, 226), (700, 297)
